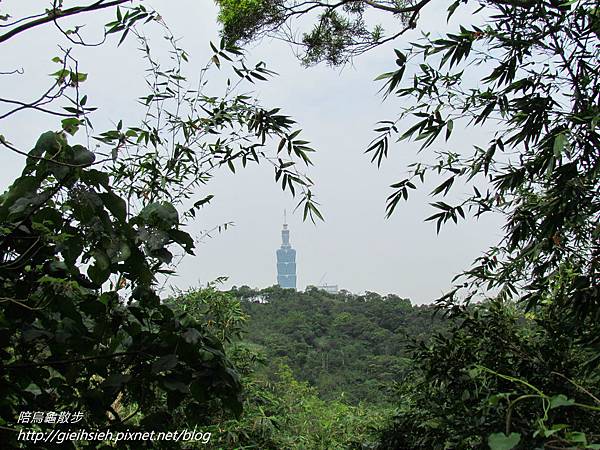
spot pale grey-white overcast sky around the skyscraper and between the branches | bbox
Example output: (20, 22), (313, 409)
(0, 0), (502, 304)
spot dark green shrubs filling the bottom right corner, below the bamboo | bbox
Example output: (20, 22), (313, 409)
(381, 301), (600, 450)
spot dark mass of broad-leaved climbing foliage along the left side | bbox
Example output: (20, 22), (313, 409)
(0, 132), (240, 446)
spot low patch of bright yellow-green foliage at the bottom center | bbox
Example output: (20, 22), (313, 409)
(213, 357), (391, 450)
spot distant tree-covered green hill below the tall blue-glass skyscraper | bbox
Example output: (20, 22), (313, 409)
(227, 287), (443, 403)
